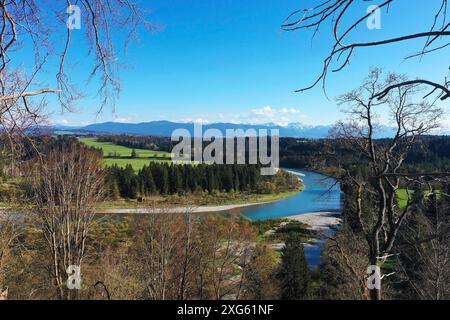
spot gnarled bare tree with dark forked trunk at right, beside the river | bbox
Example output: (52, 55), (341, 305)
(333, 69), (450, 299)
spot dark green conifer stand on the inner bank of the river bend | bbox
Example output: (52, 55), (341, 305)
(106, 162), (299, 199)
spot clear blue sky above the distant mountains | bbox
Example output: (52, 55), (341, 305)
(49, 0), (450, 125)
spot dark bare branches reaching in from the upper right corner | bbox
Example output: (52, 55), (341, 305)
(282, 0), (450, 100)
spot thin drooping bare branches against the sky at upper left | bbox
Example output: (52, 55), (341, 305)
(0, 0), (152, 147)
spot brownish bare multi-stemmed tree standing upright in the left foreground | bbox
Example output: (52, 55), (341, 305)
(29, 143), (103, 299)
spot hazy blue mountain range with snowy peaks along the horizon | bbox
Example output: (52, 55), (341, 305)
(53, 121), (448, 139)
